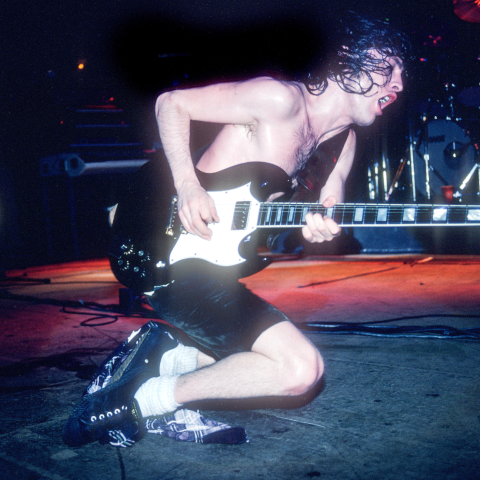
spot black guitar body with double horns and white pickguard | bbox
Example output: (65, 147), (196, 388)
(109, 161), (291, 292)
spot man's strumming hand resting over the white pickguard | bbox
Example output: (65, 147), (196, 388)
(177, 183), (220, 240)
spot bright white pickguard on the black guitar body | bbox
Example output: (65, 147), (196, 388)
(170, 183), (260, 267)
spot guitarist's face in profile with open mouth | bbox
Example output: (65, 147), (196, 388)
(352, 52), (403, 126)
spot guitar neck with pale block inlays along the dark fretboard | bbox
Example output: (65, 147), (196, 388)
(258, 202), (480, 228)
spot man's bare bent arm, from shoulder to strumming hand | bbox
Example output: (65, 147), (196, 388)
(155, 78), (298, 239)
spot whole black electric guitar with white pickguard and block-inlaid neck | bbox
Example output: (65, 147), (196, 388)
(111, 162), (480, 291)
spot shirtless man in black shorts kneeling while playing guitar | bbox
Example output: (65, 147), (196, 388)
(62, 15), (405, 450)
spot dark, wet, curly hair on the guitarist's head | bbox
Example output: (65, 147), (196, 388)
(301, 14), (411, 95)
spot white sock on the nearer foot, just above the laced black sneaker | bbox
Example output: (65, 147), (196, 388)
(135, 375), (181, 417)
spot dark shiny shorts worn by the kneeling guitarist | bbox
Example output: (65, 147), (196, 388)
(147, 274), (289, 358)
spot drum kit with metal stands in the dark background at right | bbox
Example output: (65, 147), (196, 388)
(388, 0), (480, 203)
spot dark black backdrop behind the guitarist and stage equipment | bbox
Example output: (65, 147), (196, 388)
(0, 0), (480, 268)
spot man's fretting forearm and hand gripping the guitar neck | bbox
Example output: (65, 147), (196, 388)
(302, 129), (356, 243)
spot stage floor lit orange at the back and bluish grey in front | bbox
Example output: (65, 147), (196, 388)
(0, 255), (480, 480)
